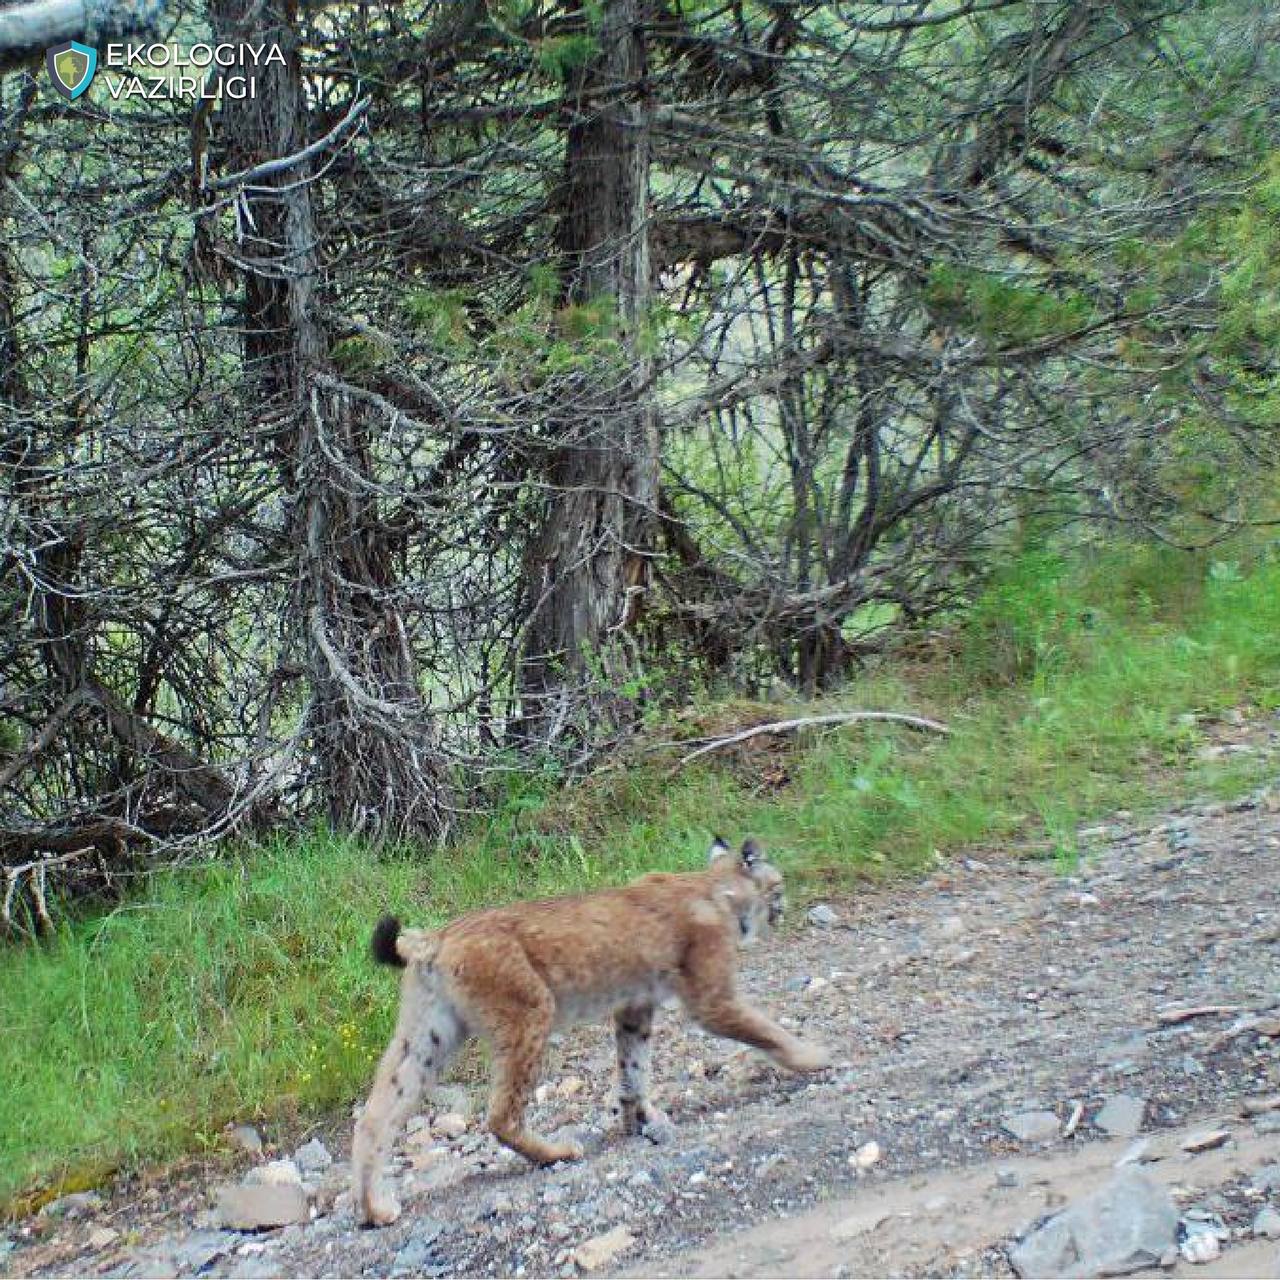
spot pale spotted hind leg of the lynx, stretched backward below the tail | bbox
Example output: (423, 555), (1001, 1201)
(351, 966), (463, 1226)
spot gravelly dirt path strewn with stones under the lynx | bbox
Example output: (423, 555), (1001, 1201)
(0, 768), (1280, 1276)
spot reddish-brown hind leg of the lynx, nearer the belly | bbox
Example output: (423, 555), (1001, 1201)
(458, 943), (582, 1165)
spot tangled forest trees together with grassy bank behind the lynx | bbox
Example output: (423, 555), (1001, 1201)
(0, 0), (1280, 1208)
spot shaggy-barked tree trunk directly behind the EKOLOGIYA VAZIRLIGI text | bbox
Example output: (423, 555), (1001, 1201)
(211, 0), (452, 838)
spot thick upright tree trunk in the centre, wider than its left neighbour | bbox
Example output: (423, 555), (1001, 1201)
(517, 0), (658, 744)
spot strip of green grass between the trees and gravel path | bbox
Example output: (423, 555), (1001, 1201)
(0, 540), (1280, 1199)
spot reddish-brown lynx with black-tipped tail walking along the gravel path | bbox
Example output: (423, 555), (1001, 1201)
(352, 837), (829, 1226)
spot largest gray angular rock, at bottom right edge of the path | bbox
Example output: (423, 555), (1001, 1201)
(1009, 1169), (1178, 1277)
